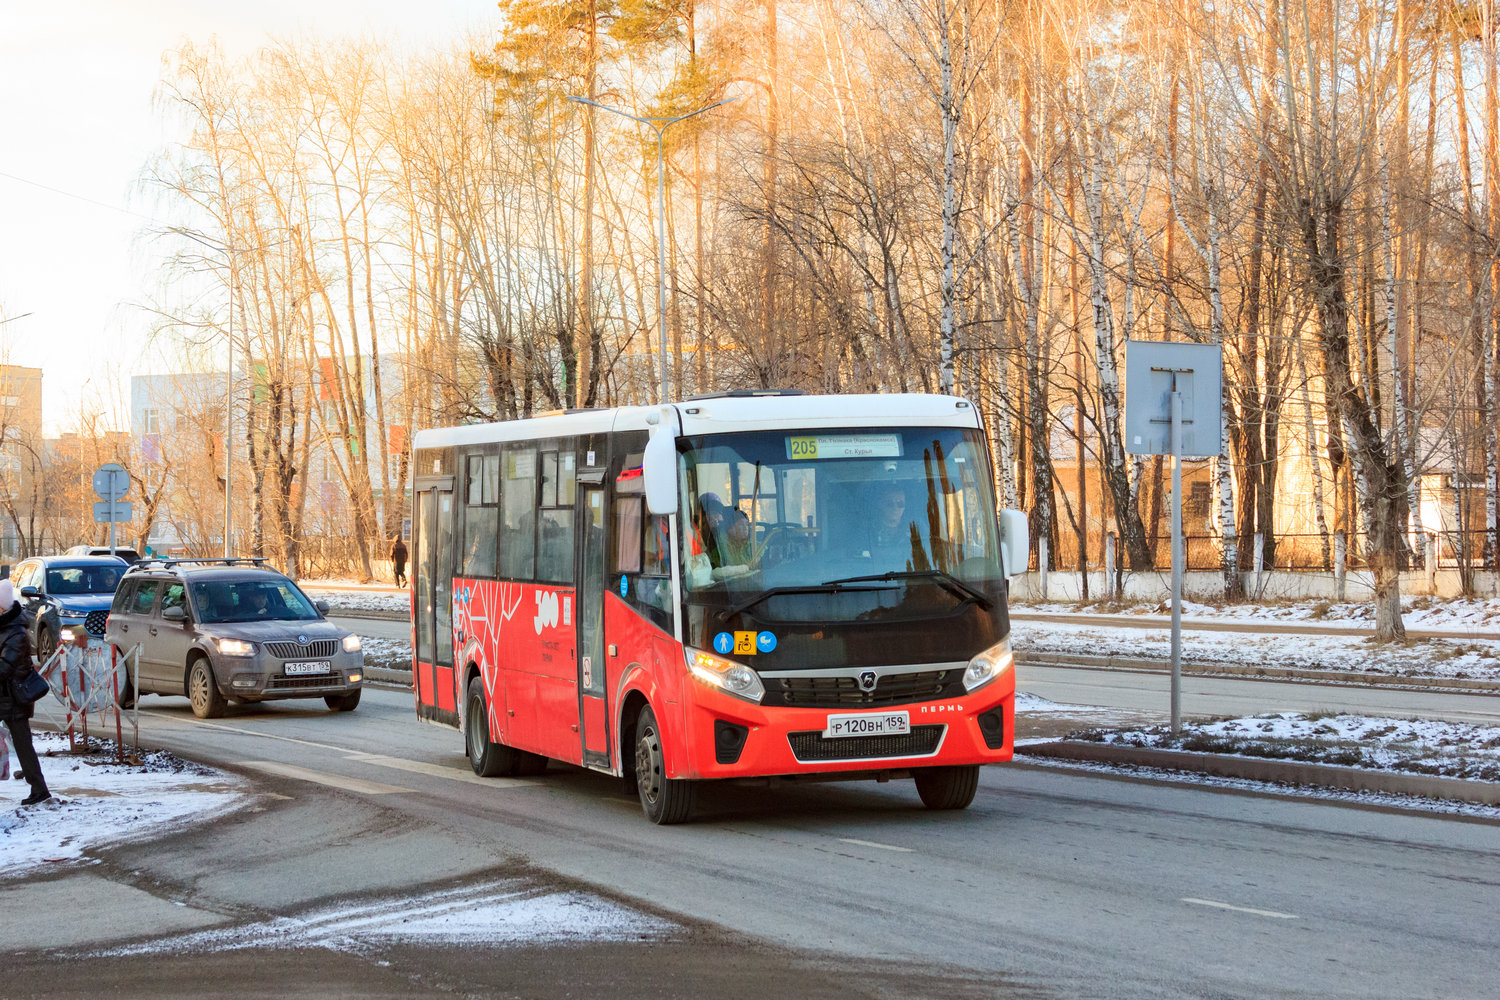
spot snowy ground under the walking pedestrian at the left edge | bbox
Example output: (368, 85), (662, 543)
(0, 732), (249, 880)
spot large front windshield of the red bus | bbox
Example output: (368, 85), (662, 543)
(680, 427), (1004, 622)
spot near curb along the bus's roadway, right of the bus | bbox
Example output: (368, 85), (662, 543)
(1016, 739), (1500, 805)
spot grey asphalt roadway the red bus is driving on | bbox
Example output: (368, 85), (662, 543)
(0, 688), (1500, 997)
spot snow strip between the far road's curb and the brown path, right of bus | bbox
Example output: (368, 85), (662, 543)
(1011, 621), (1500, 681)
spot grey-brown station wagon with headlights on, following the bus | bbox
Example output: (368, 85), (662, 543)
(105, 559), (365, 718)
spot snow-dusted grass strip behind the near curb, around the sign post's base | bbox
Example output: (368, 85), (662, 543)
(1073, 712), (1500, 781)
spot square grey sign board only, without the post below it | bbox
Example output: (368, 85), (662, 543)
(1125, 340), (1224, 457)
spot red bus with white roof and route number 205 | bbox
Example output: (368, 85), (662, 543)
(413, 391), (1028, 823)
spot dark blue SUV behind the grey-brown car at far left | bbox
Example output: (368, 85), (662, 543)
(11, 556), (128, 663)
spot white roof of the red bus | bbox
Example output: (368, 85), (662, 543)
(413, 393), (980, 448)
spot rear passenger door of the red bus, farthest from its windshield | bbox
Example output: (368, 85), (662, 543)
(413, 480), (459, 724)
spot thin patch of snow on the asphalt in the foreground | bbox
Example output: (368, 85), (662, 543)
(98, 879), (678, 957)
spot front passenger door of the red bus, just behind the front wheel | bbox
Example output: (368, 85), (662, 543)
(578, 471), (611, 768)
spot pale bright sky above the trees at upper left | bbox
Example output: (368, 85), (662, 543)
(0, 0), (500, 436)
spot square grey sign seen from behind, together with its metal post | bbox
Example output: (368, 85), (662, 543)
(1125, 340), (1224, 735)
